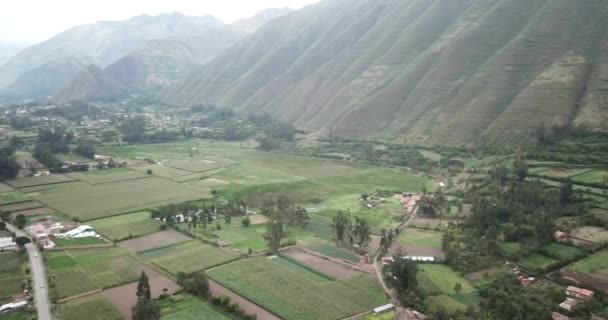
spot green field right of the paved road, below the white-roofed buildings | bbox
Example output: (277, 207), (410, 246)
(48, 248), (157, 298)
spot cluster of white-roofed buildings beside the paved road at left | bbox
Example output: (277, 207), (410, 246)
(25, 217), (101, 249)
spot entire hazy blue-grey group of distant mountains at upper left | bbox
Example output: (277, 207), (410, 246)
(0, 9), (292, 99)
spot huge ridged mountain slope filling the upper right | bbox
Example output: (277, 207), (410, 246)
(164, 0), (608, 145)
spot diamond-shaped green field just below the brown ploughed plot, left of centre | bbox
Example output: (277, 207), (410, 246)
(138, 240), (239, 275)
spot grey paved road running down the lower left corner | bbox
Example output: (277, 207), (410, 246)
(7, 224), (52, 320)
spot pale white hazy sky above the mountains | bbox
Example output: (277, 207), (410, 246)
(0, 0), (319, 44)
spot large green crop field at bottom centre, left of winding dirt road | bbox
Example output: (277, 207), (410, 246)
(207, 257), (387, 320)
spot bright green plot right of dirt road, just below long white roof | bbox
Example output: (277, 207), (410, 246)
(418, 264), (475, 295)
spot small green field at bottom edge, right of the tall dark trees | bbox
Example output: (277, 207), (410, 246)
(158, 294), (231, 320)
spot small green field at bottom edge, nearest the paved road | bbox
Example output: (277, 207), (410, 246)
(59, 297), (123, 320)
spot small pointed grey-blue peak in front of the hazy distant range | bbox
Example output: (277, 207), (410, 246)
(56, 65), (128, 101)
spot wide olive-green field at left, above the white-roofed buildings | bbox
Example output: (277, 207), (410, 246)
(34, 177), (210, 221)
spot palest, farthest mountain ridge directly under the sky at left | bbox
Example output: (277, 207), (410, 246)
(0, 13), (226, 97)
